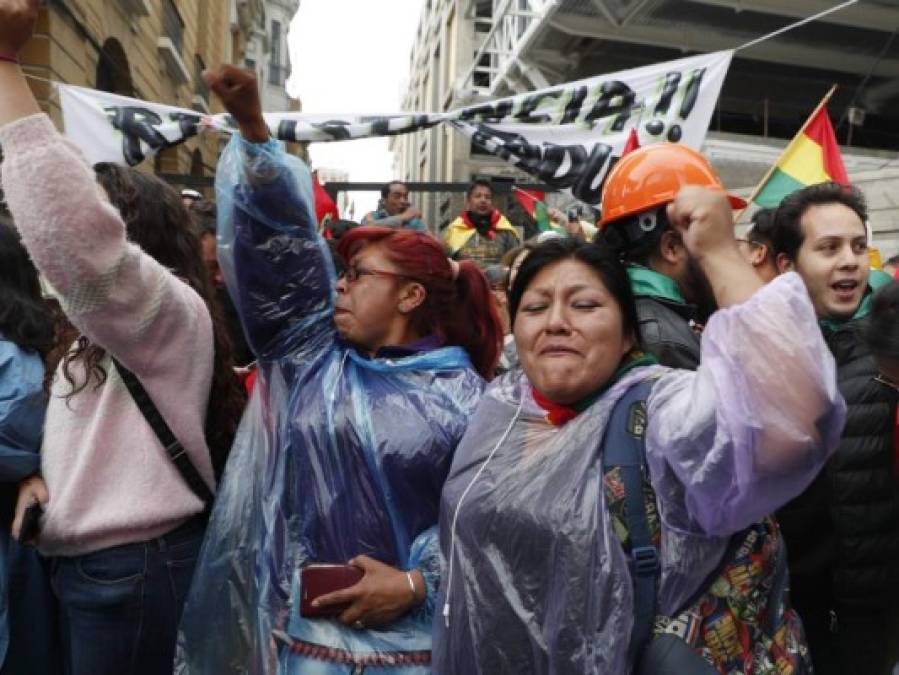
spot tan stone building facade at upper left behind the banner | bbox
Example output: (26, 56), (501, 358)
(14, 0), (299, 193)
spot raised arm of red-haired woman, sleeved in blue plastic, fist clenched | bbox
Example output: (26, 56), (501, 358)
(204, 66), (334, 359)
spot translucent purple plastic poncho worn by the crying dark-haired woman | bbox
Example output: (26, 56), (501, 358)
(434, 274), (845, 675)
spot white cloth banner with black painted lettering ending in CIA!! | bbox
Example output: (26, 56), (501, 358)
(59, 51), (733, 204)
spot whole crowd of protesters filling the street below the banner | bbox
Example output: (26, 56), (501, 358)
(0, 0), (899, 675)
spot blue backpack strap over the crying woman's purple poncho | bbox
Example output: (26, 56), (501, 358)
(602, 380), (661, 663)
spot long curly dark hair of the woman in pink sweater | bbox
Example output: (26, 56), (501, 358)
(49, 163), (246, 478)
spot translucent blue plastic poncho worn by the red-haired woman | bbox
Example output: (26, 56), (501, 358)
(176, 136), (483, 675)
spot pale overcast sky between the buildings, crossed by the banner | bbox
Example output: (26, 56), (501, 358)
(287, 0), (423, 220)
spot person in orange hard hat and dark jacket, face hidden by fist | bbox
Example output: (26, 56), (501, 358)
(594, 143), (746, 370)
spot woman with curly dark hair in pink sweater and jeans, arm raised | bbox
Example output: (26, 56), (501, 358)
(0, 0), (241, 675)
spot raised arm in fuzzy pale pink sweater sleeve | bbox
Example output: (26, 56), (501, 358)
(0, 0), (212, 375)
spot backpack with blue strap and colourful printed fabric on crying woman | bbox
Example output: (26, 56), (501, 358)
(602, 381), (812, 675)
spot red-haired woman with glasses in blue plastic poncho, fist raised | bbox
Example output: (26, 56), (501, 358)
(177, 66), (502, 675)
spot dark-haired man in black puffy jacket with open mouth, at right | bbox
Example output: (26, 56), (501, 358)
(773, 183), (899, 675)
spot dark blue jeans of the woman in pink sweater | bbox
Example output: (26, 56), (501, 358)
(53, 517), (206, 675)
